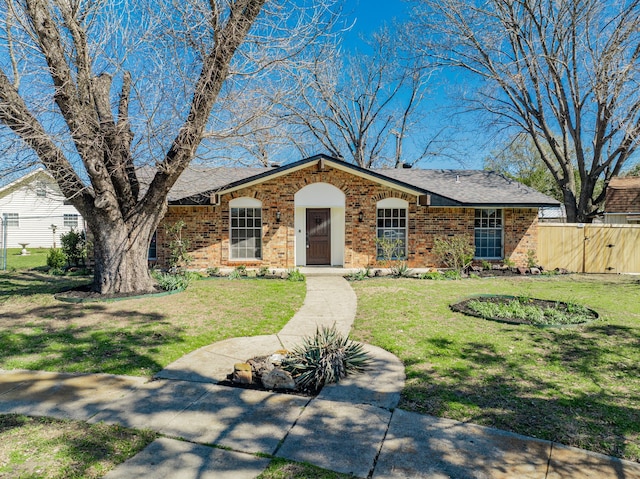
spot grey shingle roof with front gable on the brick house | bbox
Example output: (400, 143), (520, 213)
(161, 155), (559, 207)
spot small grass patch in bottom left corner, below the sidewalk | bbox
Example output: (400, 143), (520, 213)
(0, 414), (157, 479)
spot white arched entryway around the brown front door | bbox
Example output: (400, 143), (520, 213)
(294, 183), (345, 266)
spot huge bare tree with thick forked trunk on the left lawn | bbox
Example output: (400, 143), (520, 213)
(0, 0), (336, 294)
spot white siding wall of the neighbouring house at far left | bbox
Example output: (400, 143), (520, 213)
(0, 175), (84, 248)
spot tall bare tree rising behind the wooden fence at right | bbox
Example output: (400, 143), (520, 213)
(415, 0), (640, 222)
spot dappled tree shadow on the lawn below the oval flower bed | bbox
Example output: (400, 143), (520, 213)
(400, 325), (640, 461)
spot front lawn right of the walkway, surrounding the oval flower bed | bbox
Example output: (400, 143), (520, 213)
(351, 275), (640, 461)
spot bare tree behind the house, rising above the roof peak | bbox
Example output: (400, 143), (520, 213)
(283, 29), (439, 168)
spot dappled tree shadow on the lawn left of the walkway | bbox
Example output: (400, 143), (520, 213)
(0, 303), (185, 376)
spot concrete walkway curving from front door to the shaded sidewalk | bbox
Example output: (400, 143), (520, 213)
(0, 270), (640, 479)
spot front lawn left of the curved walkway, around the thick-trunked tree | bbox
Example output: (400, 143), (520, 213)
(0, 272), (305, 376)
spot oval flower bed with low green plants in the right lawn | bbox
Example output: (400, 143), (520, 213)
(451, 295), (598, 326)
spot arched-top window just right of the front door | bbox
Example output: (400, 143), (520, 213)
(376, 198), (409, 260)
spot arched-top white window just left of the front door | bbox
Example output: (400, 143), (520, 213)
(229, 198), (262, 259)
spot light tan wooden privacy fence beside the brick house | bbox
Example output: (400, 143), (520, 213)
(536, 223), (640, 273)
